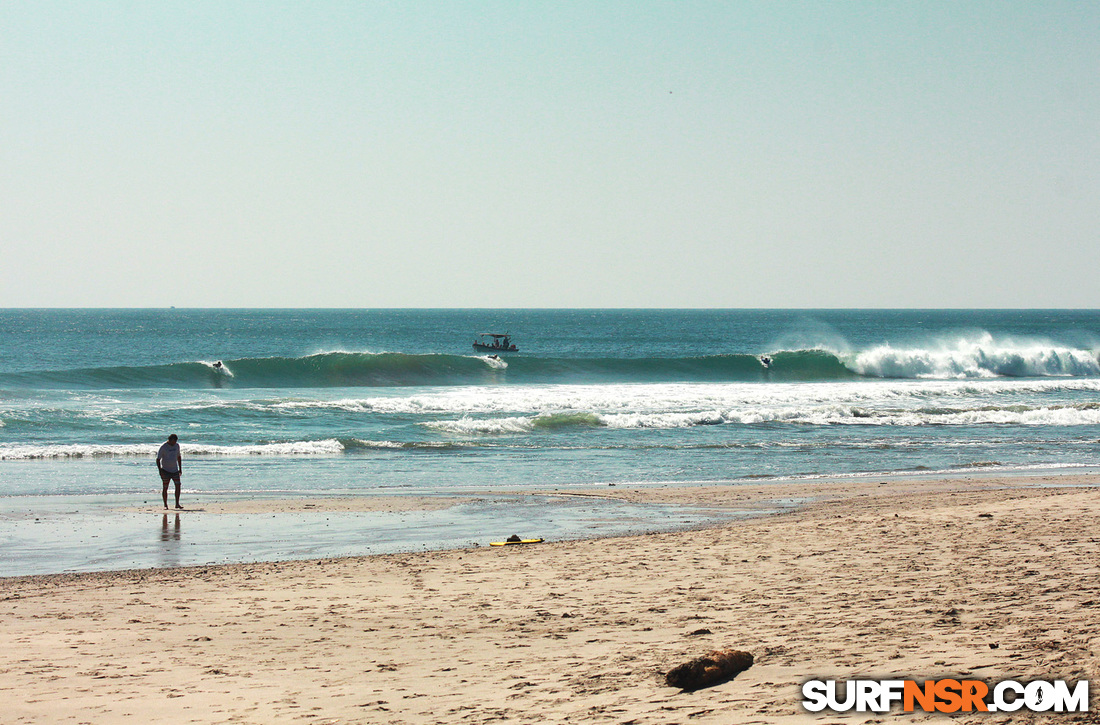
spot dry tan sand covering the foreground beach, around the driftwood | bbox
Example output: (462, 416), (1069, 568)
(0, 477), (1100, 725)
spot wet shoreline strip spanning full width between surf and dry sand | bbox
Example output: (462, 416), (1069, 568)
(0, 470), (1082, 578)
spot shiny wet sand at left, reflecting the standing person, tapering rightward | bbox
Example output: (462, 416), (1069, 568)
(0, 491), (756, 578)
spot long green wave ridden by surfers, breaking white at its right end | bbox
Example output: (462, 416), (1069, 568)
(0, 334), (1100, 389)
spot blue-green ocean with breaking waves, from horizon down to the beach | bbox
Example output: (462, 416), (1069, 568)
(0, 309), (1100, 575)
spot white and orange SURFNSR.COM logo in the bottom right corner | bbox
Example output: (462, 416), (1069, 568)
(802, 679), (1089, 713)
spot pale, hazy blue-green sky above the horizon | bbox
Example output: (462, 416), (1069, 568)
(0, 0), (1100, 308)
